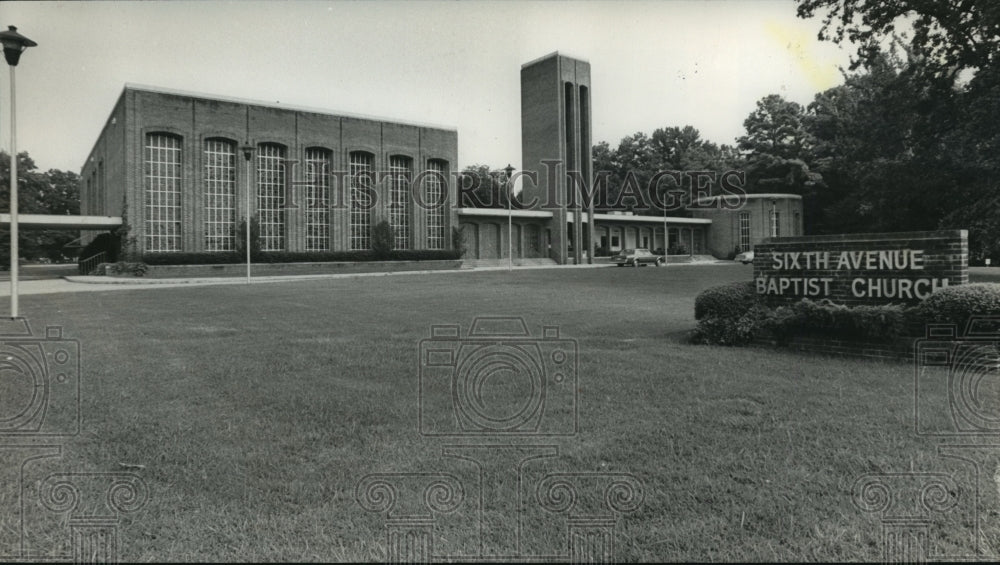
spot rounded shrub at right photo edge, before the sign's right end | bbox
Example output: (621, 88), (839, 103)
(912, 283), (1000, 333)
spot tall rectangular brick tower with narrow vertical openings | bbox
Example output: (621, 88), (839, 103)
(521, 51), (594, 264)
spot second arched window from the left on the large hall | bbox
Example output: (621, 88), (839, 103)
(205, 139), (236, 251)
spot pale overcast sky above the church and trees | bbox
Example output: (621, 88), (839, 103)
(0, 0), (848, 172)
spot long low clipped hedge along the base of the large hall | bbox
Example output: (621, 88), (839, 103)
(142, 249), (459, 265)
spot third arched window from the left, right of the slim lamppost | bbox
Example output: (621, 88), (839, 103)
(257, 143), (285, 251)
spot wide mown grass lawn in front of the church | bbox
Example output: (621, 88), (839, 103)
(0, 265), (1000, 561)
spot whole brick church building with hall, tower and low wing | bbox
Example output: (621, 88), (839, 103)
(80, 52), (803, 264)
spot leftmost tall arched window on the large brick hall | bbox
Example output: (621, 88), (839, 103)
(143, 133), (181, 252)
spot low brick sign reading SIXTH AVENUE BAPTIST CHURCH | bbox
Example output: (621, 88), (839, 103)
(753, 230), (969, 305)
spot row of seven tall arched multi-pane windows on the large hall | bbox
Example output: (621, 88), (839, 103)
(143, 133), (447, 252)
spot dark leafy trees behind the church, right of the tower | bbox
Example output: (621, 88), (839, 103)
(466, 0), (1000, 263)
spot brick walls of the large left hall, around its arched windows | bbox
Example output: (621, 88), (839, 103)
(81, 86), (458, 252)
